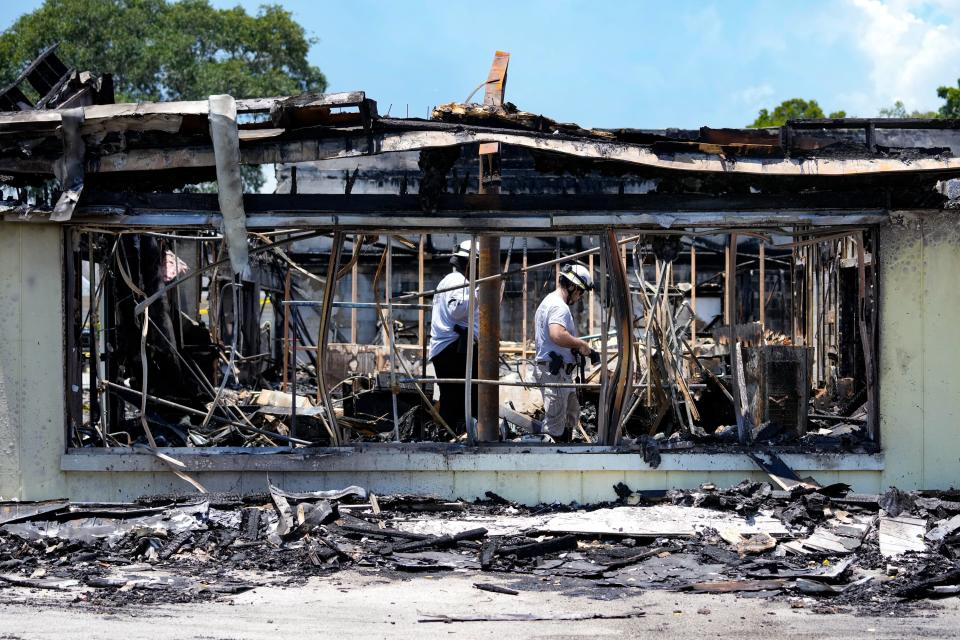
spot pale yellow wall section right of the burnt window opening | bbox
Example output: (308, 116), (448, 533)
(879, 211), (960, 489)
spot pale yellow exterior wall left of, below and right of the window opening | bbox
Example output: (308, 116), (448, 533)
(0, 212), (960, 502)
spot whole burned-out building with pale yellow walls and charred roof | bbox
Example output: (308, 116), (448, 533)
(0, 52), (960, 502)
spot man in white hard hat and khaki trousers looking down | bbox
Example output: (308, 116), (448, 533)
(533, 264), (593, 440)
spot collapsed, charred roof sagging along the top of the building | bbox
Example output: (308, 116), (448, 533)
(0, 91), (960, 202)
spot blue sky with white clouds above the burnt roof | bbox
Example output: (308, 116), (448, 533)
(0, 0), (960, 128)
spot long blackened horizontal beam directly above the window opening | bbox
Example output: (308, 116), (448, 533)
(11, 192), (889, 235)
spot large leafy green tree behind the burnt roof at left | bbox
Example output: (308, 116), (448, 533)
(0, 0), (327, 188)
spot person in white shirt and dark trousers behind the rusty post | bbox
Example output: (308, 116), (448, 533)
(427, 240), (480, 433)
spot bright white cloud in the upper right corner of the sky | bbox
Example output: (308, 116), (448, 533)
(847, 0), (960, 115)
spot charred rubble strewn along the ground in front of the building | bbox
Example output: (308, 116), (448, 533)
(0, 481), (960, 611)
